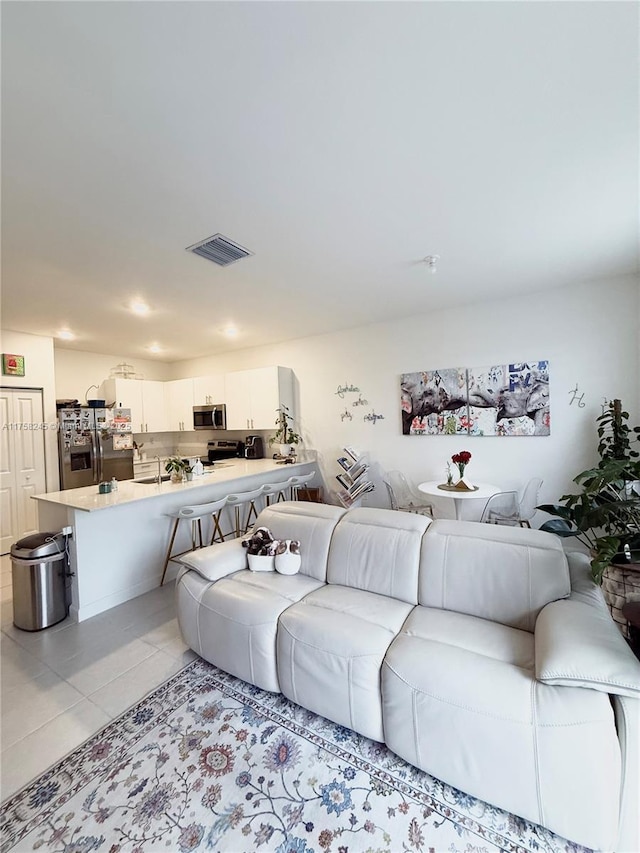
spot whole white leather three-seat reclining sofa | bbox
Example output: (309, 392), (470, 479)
(176, 502), (640, 853)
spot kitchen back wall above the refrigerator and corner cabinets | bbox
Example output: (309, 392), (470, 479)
(55, 347), (170, 405)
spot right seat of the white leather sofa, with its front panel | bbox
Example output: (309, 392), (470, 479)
(382, 608), (620, 850)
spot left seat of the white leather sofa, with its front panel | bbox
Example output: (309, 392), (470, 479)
(177, 570), (322, 692)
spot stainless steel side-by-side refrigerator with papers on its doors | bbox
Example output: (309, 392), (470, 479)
(58, 406), (133, 489)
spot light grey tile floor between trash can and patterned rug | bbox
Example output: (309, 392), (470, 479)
(0, 555), (196, 800)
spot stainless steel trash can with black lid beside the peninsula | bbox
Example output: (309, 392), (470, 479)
(11, 533), (69, 631)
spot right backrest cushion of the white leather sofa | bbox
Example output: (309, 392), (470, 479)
(419, 519), (571, 631)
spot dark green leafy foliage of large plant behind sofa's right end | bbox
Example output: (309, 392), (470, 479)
(538, 400), (640, 584)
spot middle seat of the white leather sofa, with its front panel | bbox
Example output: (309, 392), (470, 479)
(278, 585), (411, 741)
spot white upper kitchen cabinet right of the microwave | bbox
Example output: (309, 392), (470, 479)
(224, 367), (295, 432)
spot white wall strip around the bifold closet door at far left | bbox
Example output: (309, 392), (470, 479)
(0, 330), (59, 492)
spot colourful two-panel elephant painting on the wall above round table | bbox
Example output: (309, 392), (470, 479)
(400, 361), (551, 436)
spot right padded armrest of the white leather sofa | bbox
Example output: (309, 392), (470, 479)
(535, 599), (640, 698)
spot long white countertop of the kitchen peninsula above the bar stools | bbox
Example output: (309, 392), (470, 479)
(33, 453), (316, 512)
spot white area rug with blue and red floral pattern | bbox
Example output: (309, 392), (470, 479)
(0, 660), (584, 853)
